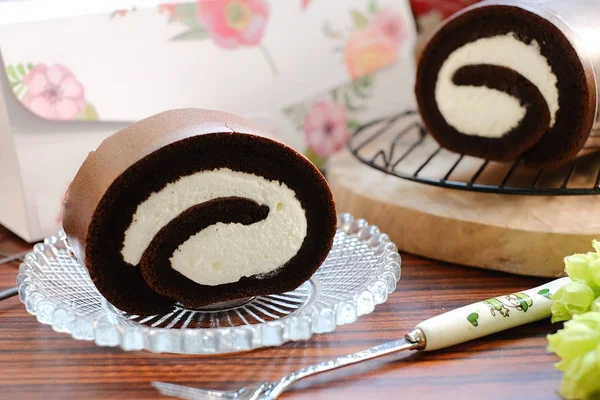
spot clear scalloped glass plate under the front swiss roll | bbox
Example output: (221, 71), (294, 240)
(17, 214), (401, 354)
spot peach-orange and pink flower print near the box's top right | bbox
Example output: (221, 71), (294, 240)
(323, 2), (407, 79)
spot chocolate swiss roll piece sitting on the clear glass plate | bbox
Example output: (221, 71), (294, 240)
(63, 109), (336, 314)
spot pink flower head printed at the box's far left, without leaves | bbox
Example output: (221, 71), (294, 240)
(22, 64), (86, 120)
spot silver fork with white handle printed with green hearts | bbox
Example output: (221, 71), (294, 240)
(152, 278), (569, 400)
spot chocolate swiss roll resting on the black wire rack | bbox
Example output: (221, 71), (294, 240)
(415, 0), (600, 168)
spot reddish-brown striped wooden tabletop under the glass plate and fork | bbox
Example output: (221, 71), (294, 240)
(0, 228), (560, 400)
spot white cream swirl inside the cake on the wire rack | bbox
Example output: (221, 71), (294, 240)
(435, 33), (559, 138)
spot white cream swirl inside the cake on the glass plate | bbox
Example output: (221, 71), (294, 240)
(121, 168), (307, 285)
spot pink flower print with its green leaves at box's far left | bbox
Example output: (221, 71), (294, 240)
(6, 63), (98, 120)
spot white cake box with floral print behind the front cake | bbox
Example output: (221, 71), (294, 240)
(0, 0), (415, 241)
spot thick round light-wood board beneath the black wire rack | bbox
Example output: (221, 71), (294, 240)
(327, 150), (600, 277)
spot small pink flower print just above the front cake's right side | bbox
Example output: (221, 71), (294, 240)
(304, 100), (350, 157)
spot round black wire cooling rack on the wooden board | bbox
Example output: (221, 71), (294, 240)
(349, 110), (600, 195)
